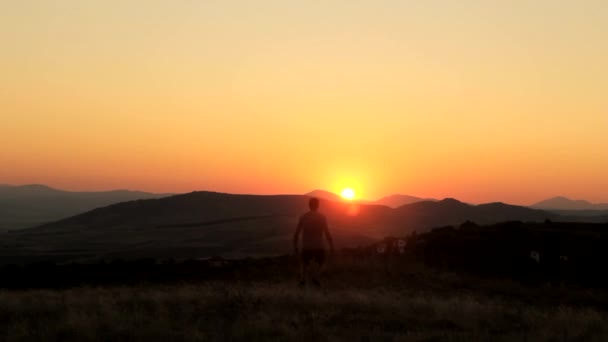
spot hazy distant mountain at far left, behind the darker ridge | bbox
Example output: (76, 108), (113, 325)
(0, 184), (169, 231)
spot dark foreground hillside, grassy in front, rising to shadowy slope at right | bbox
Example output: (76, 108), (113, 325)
(0, 222), (608, 341)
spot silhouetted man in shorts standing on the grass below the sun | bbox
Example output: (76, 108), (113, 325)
(293, 197), (334, 287)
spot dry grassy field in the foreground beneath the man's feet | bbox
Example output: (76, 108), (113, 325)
(0, 261), (608, 341)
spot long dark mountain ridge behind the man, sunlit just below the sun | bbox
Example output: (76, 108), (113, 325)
(0, 191), (559, 263)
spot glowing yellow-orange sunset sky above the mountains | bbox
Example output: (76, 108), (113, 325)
(0, 0), (608, 204)
